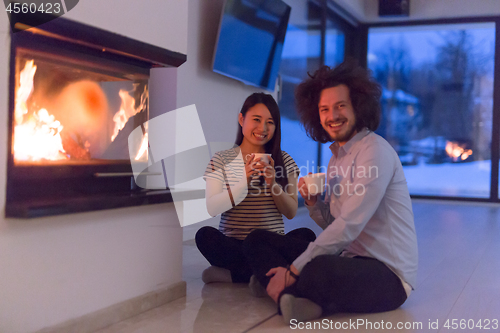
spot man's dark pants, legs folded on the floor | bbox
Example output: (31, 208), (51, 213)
(243, 230), (406, 316)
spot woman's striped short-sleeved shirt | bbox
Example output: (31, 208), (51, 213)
(203, 148), (300, 239)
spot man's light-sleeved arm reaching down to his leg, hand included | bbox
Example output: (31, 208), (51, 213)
(293, 145), (394, 271)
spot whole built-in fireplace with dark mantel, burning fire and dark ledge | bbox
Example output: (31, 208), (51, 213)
(5, 14), (186, 217)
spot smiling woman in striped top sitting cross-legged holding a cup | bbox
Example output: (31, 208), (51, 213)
(196, 93), (315, 286)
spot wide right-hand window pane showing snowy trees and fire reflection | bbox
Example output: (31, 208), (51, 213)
(367, 23), (498, 198)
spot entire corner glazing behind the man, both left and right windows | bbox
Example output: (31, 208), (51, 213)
(279, 5), (500, 201)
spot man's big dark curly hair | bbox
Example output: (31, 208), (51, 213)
(295, 60), (382, 143)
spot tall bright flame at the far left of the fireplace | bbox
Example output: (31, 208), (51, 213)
(14, 60), (68, 161)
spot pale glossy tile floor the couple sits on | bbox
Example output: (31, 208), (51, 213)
(95, 201), (500, 333)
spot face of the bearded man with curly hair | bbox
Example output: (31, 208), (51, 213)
(318, 84), (357, 146)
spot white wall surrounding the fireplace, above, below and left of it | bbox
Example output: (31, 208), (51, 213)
(0, 0), (187, 333)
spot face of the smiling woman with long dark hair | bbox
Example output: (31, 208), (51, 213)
(238, 103), (276, 146)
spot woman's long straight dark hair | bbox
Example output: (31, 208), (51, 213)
(235, 93), (288, 187)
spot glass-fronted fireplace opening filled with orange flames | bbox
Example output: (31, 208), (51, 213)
(12, 48), (148, 165)
